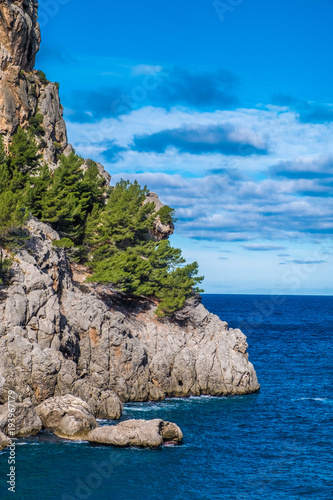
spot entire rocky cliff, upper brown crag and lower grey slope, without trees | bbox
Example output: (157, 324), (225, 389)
(0, 0), (259, 424)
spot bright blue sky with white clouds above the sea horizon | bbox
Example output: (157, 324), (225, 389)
(36, 0), (333, 294)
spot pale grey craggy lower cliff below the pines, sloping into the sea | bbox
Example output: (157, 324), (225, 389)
(0, 219), (259, 410)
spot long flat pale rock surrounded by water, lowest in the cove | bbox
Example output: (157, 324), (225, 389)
(86, 419), (183, 448)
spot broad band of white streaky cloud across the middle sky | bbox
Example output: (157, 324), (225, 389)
(64, 107), (333, 246)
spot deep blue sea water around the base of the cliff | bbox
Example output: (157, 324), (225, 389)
(0, 295), (333, 500)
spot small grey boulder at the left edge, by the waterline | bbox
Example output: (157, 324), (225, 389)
(0, 400), (42, 438)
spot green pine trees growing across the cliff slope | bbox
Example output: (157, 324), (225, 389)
(0, 127), (202, 316)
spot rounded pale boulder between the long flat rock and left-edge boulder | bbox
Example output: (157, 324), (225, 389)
(36, 394), (98, 440)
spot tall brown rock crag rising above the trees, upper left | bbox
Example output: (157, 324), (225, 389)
(0, 0), (71, 165)
